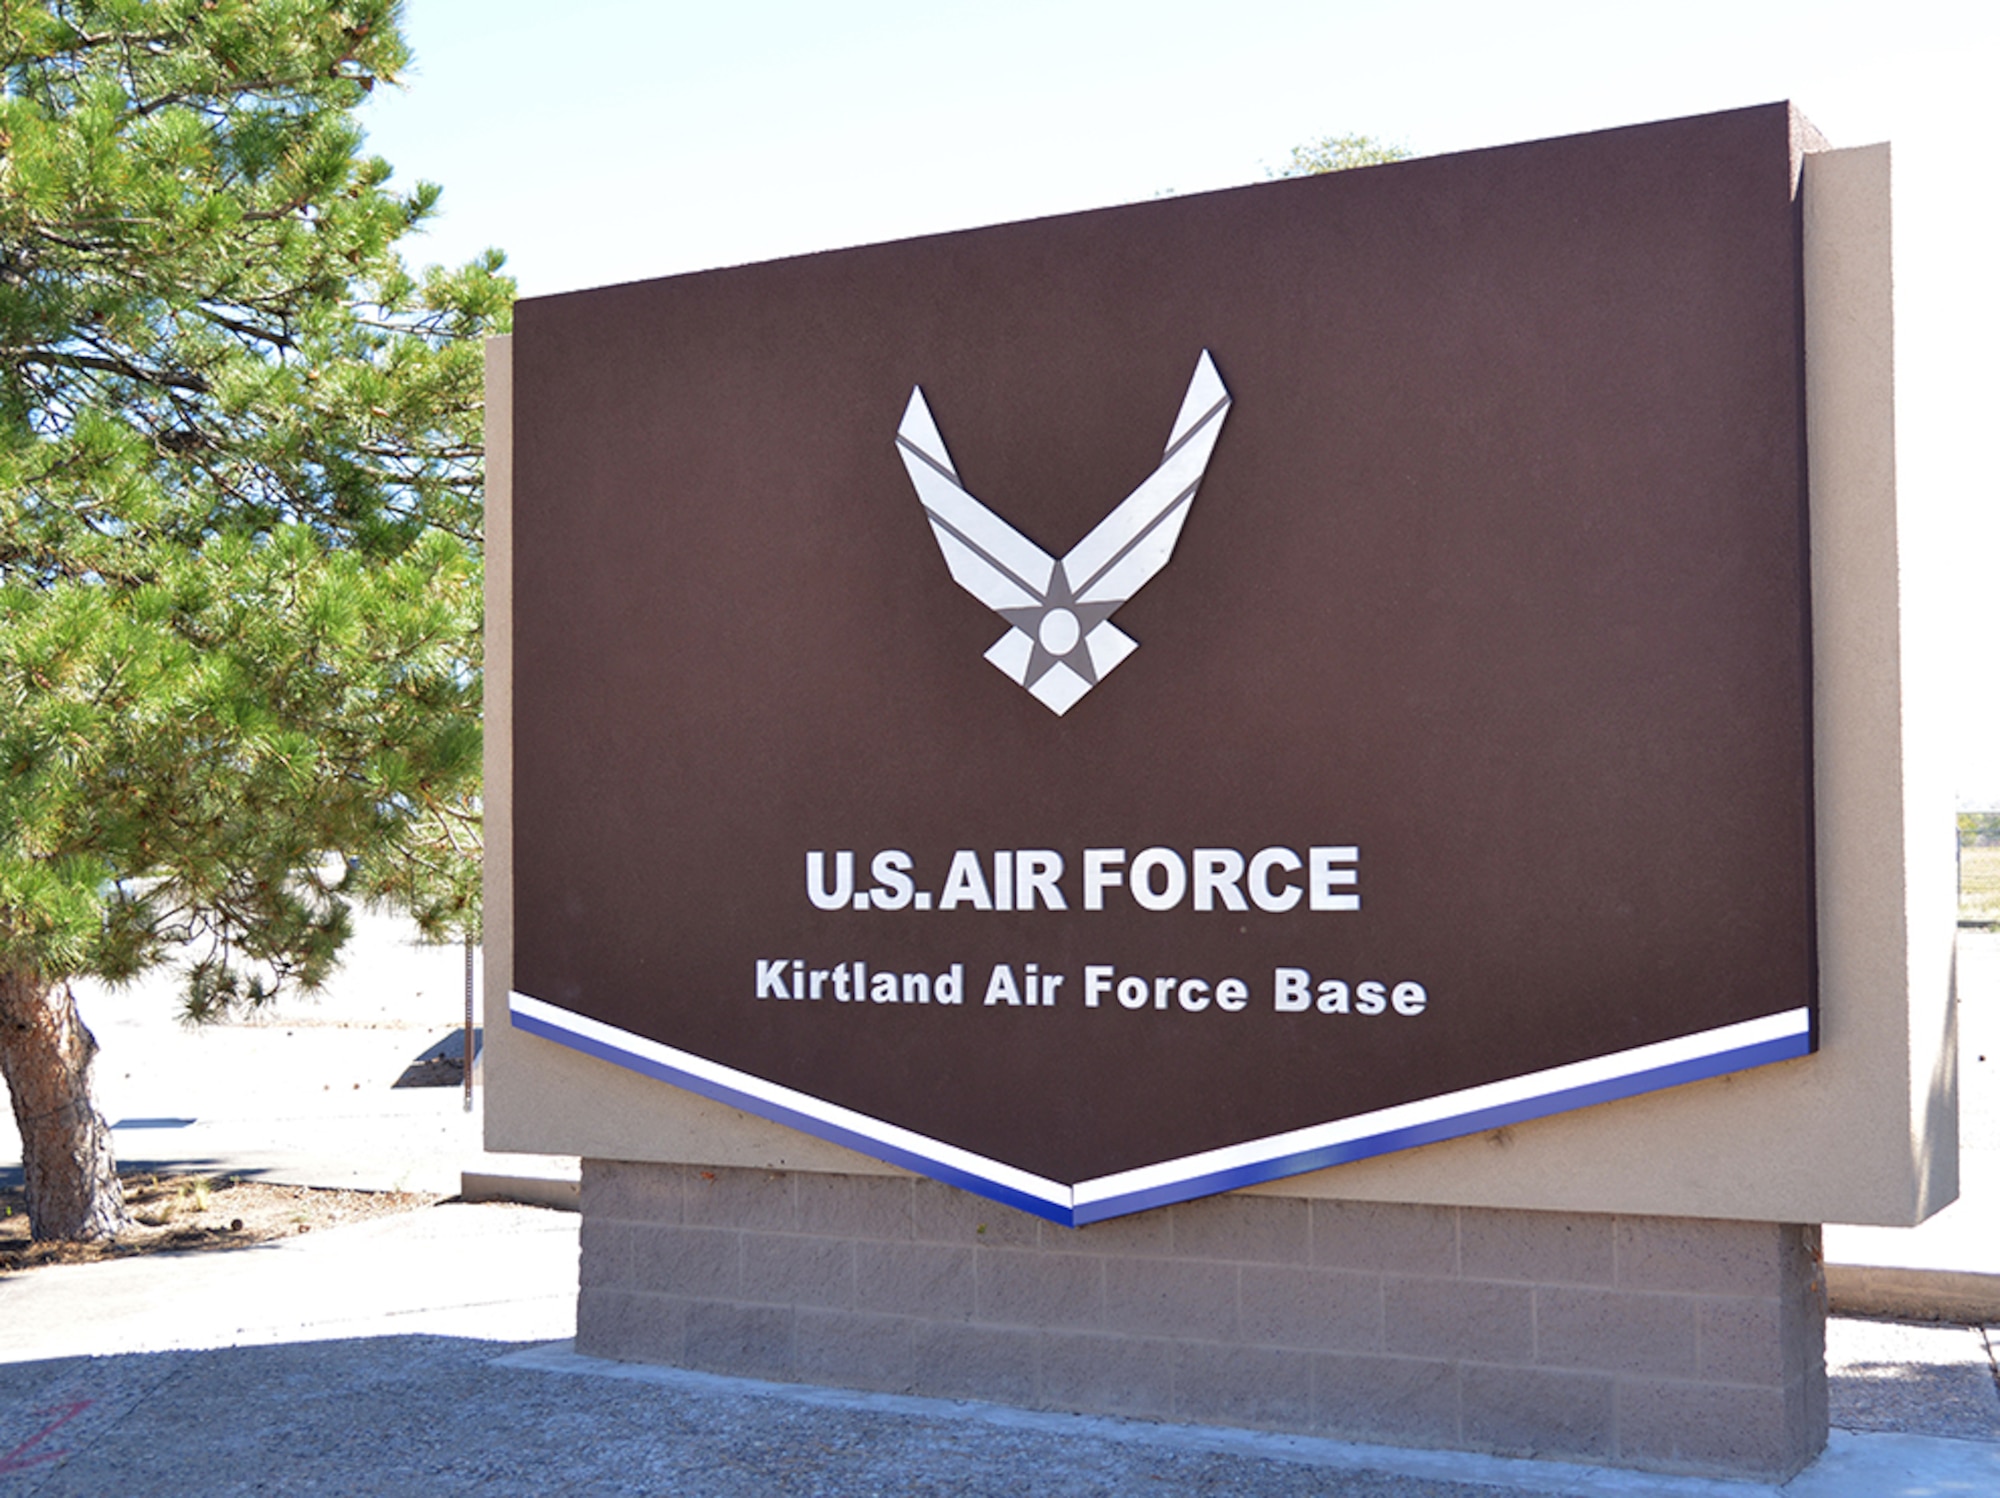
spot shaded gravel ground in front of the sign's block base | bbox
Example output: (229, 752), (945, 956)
(0, 1336), (1496, 1498)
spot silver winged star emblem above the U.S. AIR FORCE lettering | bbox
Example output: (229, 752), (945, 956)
(896, 348), (1230, 718)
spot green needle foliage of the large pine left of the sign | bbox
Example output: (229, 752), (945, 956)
(0, 0), (512, 1016)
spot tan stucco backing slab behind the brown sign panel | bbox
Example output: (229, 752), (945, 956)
(486, 146), (1958, 1224)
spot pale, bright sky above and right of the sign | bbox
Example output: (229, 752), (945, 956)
(362, 0), (2000, 806)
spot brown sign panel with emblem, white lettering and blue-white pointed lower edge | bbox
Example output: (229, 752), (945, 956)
(512, 106), (1814, 1222)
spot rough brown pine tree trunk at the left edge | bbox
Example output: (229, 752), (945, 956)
(0, 970), (128, 1240)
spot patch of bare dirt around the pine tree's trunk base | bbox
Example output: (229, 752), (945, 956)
(0, 1172), (442, 1274)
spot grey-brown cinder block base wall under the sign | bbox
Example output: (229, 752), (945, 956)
(576, 1160), (1826, 1478)
